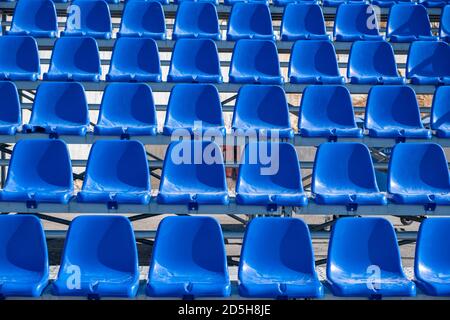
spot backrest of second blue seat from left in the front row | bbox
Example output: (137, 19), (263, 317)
(59, 215), (139, 275)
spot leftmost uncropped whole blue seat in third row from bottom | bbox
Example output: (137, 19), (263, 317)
(23, 82), (89, 136)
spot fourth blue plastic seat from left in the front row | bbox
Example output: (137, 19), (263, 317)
(238, 217), (323, 298)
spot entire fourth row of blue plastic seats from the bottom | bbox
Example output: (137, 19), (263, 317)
(0, 36), (450, 85)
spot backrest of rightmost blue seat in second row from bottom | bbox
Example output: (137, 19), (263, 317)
(387, 143), (450, 193)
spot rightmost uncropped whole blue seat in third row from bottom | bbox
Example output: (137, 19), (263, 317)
(364, 86), (431, 139)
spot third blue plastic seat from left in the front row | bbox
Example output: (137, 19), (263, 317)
(147, 216), (231, 298)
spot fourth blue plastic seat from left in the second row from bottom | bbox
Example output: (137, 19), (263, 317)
(236, 141), (308, 211)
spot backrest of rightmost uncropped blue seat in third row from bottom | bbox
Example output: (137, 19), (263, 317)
(364, 86), (423, 129)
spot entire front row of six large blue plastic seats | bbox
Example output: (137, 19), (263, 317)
(0, 215), (450, 299)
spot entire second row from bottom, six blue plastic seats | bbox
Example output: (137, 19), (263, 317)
(0, 139), (450, 211)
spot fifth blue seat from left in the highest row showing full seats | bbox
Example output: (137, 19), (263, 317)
(227, 2), (275, 41)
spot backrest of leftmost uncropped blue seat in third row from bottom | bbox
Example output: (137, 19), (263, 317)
(30, 82), (89, 126)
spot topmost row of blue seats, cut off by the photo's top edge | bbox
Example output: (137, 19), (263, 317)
(0, 0), (449, 8)
